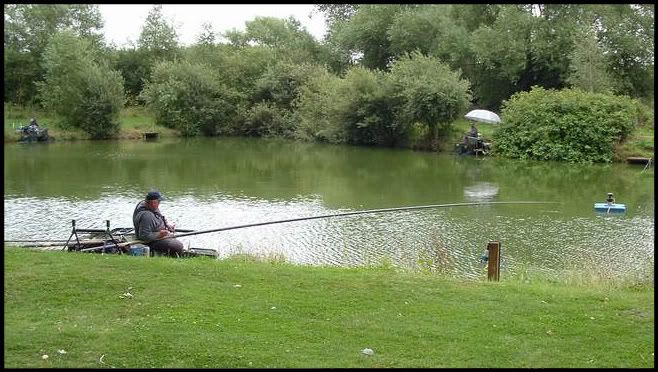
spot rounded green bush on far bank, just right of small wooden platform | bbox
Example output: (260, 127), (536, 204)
(142, 62), (236, 136)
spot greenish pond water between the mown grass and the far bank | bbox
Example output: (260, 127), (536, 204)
(4, 138), (654, 280)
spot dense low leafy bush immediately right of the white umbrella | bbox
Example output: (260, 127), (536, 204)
(494, 87), (640, 163)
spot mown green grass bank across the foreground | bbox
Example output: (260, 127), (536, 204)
(4, 248), (654, 368)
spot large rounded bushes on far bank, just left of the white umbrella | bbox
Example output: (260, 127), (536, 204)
(295, 53), (469, 146)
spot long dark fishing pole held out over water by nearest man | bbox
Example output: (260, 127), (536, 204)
(151, 201), (557, 243)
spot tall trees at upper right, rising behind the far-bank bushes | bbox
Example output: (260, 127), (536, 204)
(329, 4), (654, 109)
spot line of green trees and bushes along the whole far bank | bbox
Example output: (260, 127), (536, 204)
(4, 4), (654, 160)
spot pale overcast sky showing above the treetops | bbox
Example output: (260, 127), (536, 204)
(98, 4), (326, 46)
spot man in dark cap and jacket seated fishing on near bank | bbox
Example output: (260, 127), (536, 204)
(133, 190), (183, 257)
